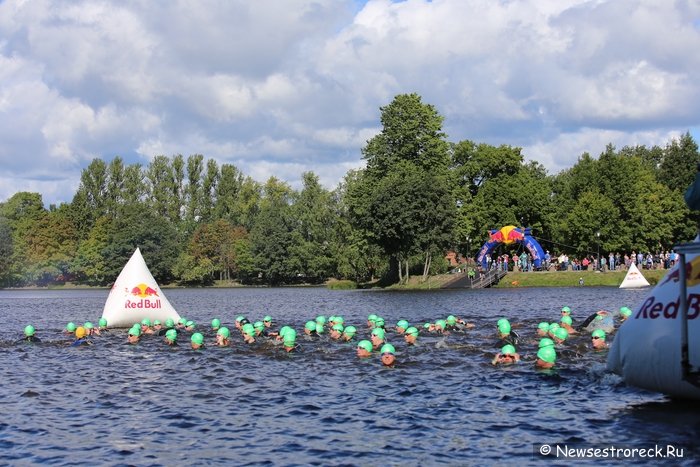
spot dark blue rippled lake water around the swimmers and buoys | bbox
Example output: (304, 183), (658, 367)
(0, 287), (700, 465)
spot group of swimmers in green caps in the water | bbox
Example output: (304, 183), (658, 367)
(13, 306), (632, 369)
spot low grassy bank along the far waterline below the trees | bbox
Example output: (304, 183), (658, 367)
(0, 269), (670, 290)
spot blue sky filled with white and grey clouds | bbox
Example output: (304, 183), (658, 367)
(0, 0), (700, 204)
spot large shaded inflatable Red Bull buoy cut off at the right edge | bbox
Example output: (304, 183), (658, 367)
(607, 245), (700, 400)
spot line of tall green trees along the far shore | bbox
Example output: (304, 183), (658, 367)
(0, 94), (700, 287)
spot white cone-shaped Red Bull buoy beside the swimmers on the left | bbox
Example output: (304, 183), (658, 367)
(102, 248), (180, 327)
